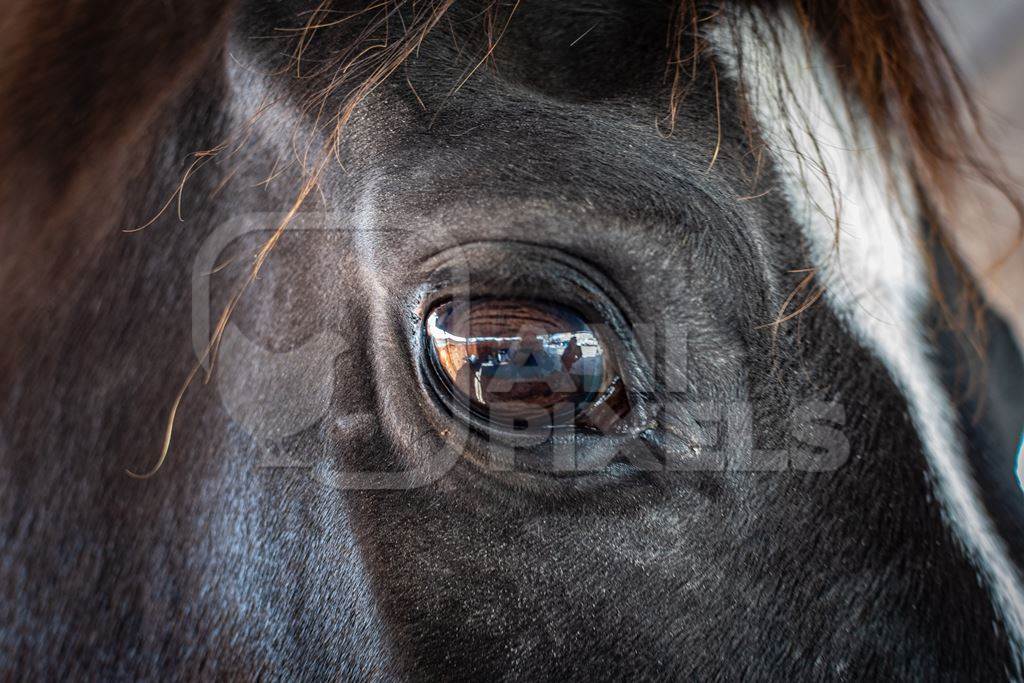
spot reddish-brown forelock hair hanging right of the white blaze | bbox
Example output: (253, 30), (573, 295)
(755, 0), (1024, 352)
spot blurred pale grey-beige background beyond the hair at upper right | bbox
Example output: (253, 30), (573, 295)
(933, 0), (1024, 342)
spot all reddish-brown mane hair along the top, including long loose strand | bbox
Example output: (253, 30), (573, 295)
(0, 0), (1011, 471)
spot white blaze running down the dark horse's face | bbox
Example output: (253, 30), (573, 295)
(711, 7), (1024, 659)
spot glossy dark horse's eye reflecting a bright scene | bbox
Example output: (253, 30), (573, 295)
(426, 299), (628, 432)
